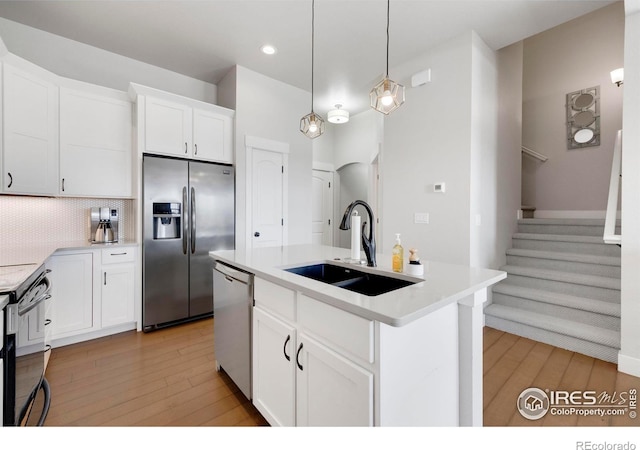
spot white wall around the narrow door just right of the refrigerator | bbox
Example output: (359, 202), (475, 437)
(219, 66), (314, 248)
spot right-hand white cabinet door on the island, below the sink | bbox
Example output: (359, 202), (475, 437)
(296, 333), (373, 426)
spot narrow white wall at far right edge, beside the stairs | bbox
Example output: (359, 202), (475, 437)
(618, 0), (640, 376)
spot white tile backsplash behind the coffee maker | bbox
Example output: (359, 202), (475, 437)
(0, 195), (135, 248)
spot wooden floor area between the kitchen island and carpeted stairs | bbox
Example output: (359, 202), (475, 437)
(483, 327), (640, 427)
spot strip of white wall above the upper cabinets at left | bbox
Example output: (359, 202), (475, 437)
(0, 18), (217, 103)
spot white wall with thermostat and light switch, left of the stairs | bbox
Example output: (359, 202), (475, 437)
(379, 33), (472, 264)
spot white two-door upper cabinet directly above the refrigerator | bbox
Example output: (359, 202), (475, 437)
(129, 83), (234, 163)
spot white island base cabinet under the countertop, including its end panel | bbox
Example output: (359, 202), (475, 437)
(252, 277), (460, 426)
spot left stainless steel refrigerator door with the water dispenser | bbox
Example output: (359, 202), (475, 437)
(142, 155), (189, 329)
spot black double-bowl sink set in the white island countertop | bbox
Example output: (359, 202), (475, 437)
(285, 263), (415, 296)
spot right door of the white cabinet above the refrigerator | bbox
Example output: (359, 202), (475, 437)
(193, 109), (232, 163)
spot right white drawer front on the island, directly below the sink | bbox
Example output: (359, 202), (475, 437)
(298, 295), (374, 363)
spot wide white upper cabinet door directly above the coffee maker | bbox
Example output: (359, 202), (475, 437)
(60, 88), (132, 197)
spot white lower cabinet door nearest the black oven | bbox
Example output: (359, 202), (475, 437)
(47, 253), (95, 339)
